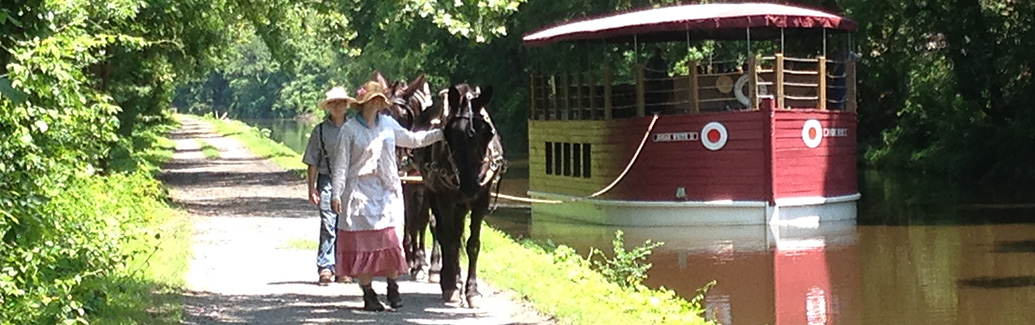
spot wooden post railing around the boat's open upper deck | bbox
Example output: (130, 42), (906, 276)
(529, 54), (856, 120)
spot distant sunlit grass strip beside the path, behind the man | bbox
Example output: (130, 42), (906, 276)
(194, 116), (306, 176)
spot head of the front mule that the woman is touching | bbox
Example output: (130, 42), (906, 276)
(442, 85), (496, 199)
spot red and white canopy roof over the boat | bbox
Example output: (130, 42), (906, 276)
(523, 3), (856, 47)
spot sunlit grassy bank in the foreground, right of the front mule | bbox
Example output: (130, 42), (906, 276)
(479, 225), (714, 324)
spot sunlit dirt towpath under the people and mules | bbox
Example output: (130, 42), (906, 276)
(161, 118), (551, 324)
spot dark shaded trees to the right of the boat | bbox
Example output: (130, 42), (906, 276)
(840, 0), (1035, 182)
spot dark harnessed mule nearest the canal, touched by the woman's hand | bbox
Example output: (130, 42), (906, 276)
(418, 84), (506, 307)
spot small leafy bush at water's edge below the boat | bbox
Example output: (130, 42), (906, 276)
(586, 230), (664, 288)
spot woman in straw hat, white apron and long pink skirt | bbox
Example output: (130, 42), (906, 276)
(331, 82), (442, 311)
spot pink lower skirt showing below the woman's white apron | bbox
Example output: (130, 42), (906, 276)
(334, 227), (409, 277)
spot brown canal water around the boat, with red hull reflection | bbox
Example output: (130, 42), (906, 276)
(244, 120), (1035, 324)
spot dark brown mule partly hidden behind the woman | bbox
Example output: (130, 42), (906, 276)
(374, 72), (442, 282)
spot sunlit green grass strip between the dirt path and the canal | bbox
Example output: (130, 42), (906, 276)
(188, 114), (707, 324)
